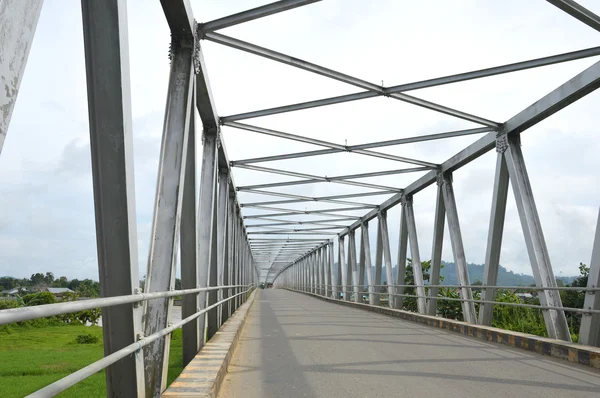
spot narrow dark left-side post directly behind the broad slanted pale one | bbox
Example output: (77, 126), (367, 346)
(180, 88), (200, 366)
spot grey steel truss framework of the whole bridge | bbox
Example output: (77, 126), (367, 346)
(0, 0), (600, 397)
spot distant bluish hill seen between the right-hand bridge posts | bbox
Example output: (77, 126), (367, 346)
(330, 261), (575, 286)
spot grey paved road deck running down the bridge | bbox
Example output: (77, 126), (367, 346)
(219, 289), (600, 398)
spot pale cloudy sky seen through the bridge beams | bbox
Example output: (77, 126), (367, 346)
(0, 0), (600, 279)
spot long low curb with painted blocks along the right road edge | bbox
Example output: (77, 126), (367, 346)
(286, 289), (600, 369)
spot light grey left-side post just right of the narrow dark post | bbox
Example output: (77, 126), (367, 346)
(198, 129), (217, 348)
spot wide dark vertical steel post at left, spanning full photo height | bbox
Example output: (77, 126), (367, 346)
(80, 0), (145, 397)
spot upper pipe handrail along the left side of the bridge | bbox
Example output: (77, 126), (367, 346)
(0, 285), (251, 325)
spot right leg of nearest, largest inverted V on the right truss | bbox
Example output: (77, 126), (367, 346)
(504, 135), (571, 341)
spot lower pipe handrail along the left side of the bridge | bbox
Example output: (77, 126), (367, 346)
(27, 285), (252, 398)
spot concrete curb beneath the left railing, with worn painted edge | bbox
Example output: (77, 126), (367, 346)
(161, 290), (256, 398)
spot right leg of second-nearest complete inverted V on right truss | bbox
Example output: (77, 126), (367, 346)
(442, 173), (477, 323)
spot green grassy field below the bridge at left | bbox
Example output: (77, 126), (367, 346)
(0, 325), (182, 398)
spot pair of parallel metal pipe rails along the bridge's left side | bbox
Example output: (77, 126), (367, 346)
(0, 284), (254, 398)
